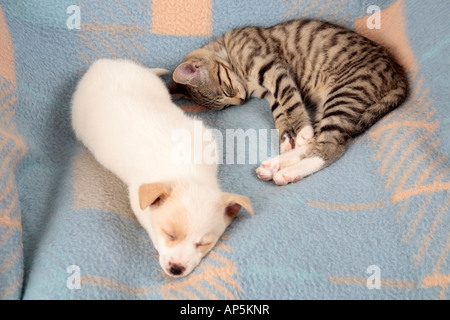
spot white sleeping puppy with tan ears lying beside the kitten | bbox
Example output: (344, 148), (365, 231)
(72, 59), (253, 277)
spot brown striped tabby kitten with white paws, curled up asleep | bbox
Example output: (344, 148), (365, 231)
(170, 20), (408, 185)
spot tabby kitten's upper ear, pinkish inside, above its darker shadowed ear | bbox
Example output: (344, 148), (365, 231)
(172, 60), (209, 87)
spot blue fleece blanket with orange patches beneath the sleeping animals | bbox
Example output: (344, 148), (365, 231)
(0, 0), (450, 299)
